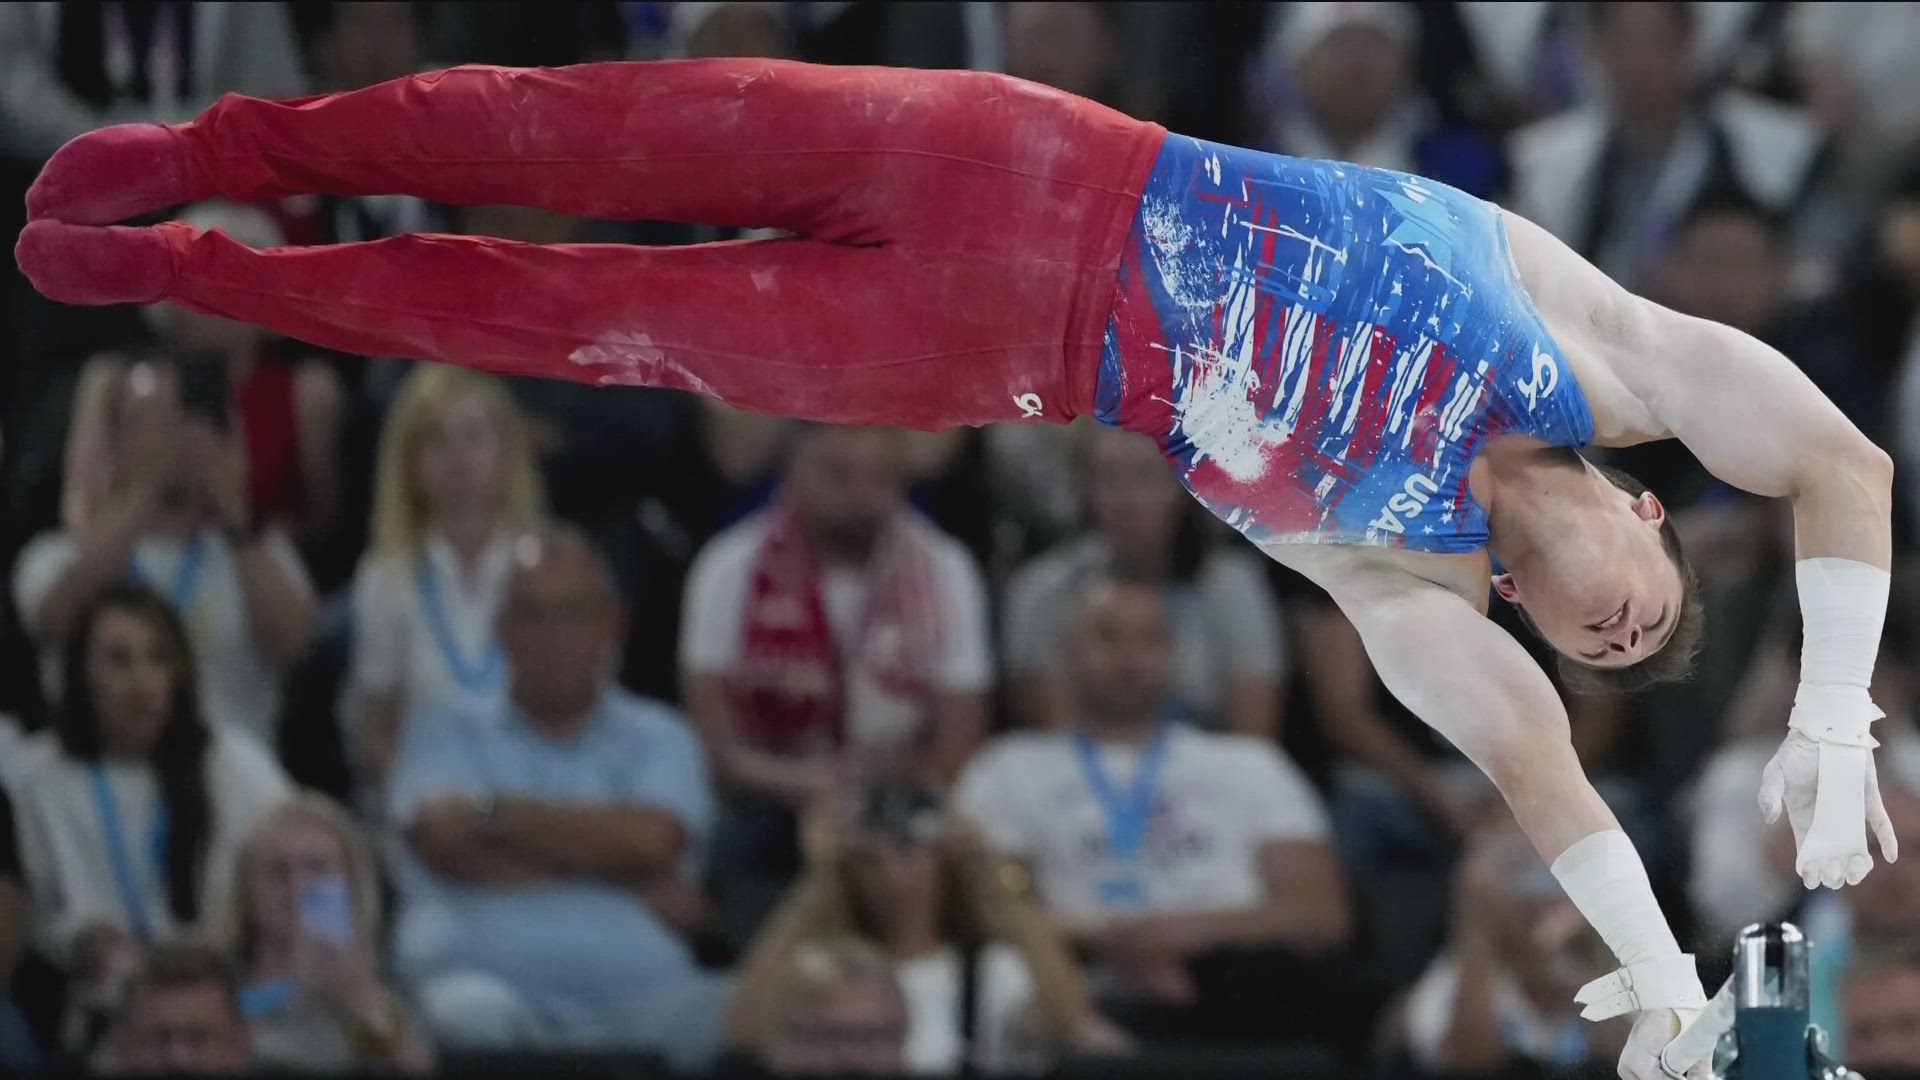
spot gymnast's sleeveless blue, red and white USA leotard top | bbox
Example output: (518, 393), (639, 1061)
(1098, 135), (1594, 552)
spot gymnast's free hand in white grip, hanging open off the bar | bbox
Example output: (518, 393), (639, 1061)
(1761, 684), (1899, 888)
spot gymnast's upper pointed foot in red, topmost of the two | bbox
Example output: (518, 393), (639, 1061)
(27, 123), (192, 225)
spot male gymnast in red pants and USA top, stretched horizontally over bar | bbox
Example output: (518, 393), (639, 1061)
(17, 60), (1897, 1080)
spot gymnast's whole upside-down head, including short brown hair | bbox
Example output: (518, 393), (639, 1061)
(1494, 459), (1705, 692)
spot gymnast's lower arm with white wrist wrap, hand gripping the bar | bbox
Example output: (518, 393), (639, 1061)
(1331, 569), (1705, 1080)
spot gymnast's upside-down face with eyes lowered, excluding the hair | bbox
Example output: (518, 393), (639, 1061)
(1494, 477), (1686, 667)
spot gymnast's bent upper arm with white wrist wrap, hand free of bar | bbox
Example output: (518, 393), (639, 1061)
(1507, 215), (1899, 888)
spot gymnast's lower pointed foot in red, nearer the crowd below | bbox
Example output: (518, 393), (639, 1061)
(13, 221), (173, 304)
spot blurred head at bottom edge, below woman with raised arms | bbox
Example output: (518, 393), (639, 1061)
(743, 938), (912, 1076)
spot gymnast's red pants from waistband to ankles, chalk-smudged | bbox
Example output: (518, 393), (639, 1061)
(142, 60), (1165, 429)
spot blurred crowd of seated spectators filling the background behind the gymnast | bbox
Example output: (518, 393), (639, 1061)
(0, 0), (1920, 1076)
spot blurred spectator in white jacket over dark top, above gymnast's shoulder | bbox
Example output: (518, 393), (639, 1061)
(1507, 2), (1822, 288)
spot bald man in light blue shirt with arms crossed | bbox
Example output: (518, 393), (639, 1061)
(390, 530), (724, 1063)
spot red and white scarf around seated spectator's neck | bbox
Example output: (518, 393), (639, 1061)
(733, 505), (943, 753)
